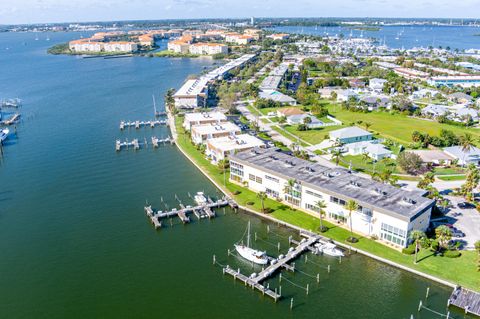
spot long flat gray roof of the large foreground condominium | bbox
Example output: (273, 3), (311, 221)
(230, 148), (434, 221)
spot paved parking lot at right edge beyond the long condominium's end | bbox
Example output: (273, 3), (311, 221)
(445, 196), (480, 249)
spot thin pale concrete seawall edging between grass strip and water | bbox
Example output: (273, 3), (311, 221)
(167, 111), (458, 289)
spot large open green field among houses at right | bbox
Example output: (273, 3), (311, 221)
(329, 106), (480, 146)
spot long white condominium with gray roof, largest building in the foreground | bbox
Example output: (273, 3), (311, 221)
(230, 149), (434, 248)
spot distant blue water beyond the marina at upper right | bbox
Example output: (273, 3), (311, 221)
(275, 26), (480, 50)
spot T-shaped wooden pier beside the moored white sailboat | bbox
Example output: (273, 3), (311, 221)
(222, 233), (321, 302)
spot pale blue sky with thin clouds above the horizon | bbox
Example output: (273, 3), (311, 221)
(0, 0), (480, 24)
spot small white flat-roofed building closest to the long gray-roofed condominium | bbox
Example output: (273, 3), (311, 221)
(205, 134), (265, 163)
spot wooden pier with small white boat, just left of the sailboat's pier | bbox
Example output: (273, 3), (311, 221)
(144, 198), (238, 229)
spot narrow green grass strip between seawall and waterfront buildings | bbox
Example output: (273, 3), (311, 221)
(175, 118), (480, 290)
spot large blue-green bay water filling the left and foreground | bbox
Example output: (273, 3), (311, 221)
(0, 33), (472, 319)
